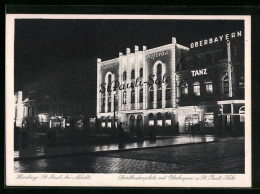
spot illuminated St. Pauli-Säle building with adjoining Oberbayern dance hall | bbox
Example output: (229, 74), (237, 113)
(96, 31), (245, 134)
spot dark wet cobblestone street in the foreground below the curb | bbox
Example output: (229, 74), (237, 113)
(14, 138), (245, 173)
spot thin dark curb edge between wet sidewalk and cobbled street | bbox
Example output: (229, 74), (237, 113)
(14, 140), (219, 161)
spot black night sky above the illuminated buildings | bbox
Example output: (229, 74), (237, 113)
(15, 19), (244, 91)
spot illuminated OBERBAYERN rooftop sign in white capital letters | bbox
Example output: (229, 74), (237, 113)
(190, 31), (242, 48)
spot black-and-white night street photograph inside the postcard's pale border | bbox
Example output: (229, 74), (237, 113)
(14, 19), (246, 174)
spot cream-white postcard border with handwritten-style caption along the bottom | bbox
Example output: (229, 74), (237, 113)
(5, 14), (252, 187)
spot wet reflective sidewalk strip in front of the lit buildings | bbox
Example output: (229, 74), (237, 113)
(14, 135), (218, 161)
